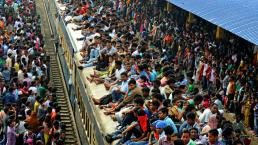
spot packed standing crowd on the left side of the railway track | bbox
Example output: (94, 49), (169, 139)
(0, 0), (65, 145)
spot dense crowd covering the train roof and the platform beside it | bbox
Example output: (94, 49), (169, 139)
(64, 0), (258, 145)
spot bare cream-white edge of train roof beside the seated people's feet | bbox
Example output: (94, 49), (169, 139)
(56, 3), (118, 137)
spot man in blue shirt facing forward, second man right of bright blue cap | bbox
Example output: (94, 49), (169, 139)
(179, 112), (200, 134)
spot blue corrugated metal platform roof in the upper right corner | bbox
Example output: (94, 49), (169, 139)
(167, 0), (258, 45)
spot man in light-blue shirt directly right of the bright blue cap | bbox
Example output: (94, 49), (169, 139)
(159, 107), (178, 133)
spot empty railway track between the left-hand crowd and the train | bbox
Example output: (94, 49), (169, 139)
(36, 0), (80, 145)
